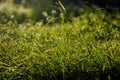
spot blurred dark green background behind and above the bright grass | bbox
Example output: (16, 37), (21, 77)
(0, 0), (120, 23)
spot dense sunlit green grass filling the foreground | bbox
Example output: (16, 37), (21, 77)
(0, 7), (120, 80)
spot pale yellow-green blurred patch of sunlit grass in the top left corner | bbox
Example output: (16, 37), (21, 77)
(0, 3), (32, 17)
